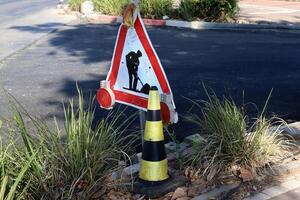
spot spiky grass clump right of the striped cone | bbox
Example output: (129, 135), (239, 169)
(188, 88), (293, 178)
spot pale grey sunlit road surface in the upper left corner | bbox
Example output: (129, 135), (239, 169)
(0, 0), (75, 62)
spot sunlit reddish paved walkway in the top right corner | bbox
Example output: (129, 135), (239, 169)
(239, 0), (300, 25)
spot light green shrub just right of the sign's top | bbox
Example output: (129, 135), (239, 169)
(140, 0), (172, 18)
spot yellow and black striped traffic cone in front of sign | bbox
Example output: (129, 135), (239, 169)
(139, 87), (169, 184)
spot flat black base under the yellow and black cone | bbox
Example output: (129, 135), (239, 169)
(124, 176), (187, 198)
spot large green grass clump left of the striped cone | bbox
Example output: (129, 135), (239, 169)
(0, 90), (136, 200)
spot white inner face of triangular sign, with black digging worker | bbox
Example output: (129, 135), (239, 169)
(114, 28), (162, 97)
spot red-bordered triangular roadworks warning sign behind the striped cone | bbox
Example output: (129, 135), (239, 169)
(97, 11), (177, 123)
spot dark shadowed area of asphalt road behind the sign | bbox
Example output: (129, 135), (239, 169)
(9, 25), (300, 138)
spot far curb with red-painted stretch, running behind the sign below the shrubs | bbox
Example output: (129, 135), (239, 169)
(87, 13), (300, 31)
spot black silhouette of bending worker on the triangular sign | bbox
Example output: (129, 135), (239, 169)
(126, 50), (142, 91)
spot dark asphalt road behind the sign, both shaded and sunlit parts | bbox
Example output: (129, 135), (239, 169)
(0, 24), (300, 139)
